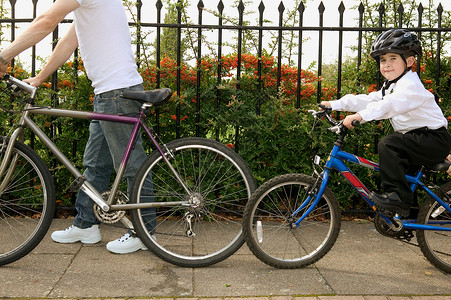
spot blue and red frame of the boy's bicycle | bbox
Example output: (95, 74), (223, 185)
(293, 135), (451, 231)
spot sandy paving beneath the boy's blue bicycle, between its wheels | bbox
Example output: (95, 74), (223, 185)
(316, 222), (451, 295)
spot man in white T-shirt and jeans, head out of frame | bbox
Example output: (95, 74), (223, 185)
(0, 0), (152, 253)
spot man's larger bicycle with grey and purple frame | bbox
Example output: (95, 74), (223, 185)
(0, 75), (256, 267)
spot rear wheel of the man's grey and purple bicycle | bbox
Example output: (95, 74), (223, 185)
(130, 138), (256, 267)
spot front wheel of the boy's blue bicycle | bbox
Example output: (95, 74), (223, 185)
(243, 174), (341, 269)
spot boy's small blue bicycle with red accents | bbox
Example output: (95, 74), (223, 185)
(243, 105), (451, 273)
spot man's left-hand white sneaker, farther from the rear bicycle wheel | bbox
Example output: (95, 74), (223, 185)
(52, 225), (102, 244)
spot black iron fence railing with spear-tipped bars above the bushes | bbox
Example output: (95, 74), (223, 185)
(0, 0), (451, 123)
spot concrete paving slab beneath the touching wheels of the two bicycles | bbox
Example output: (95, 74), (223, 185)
(194, 253), (332, 297)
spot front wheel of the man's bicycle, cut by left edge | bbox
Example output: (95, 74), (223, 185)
(0, 137), (56, 265)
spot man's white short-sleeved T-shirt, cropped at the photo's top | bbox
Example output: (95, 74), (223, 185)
(74, 0), (142, 94)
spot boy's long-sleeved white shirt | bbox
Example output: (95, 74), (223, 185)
(330, 71), (448, 133)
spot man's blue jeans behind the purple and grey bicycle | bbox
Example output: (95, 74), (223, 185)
(74, 85), (155, 230)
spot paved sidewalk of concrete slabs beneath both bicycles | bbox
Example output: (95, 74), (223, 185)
(0, 219), (451, 300)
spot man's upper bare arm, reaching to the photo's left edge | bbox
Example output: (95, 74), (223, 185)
(0, 0), (80, 76)
